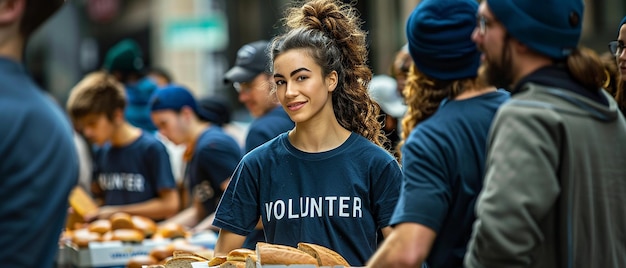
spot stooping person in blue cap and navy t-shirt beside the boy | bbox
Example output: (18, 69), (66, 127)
(149, 85), (241, 231)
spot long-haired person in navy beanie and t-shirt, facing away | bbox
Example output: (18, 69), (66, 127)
(368, 0), (509, 268)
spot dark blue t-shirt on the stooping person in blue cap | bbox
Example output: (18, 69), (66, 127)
(186, 126), (241, 215)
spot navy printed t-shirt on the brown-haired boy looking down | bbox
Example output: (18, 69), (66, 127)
(94, 132), (176, 205)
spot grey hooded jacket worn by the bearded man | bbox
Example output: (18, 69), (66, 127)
(465, 83), (626, 268)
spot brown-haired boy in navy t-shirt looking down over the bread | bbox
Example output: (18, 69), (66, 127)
(67, 72), (179, 220)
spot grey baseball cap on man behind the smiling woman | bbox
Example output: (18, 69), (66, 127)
(224, 40), (270, 83)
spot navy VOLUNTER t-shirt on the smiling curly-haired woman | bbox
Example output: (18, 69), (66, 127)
(213, 133), (402, 266)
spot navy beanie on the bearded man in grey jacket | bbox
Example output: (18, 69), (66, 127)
(487, 0), (584, 59)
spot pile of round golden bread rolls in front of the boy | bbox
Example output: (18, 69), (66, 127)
(62, 212), (188, 247)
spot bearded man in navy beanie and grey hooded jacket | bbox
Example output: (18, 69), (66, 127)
(465, 0), (626, 267)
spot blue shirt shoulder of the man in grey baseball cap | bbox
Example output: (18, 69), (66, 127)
(245, 106), (294, 152)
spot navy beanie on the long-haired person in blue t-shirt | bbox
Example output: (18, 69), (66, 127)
(406, 0), (480, 80)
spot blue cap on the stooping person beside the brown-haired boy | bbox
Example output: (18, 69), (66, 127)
(150, 85), (220, 123)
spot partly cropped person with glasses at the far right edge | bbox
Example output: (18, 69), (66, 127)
(609, 17), (626, 112)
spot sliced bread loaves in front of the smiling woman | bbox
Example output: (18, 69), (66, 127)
(206, 243), (350, 268)
